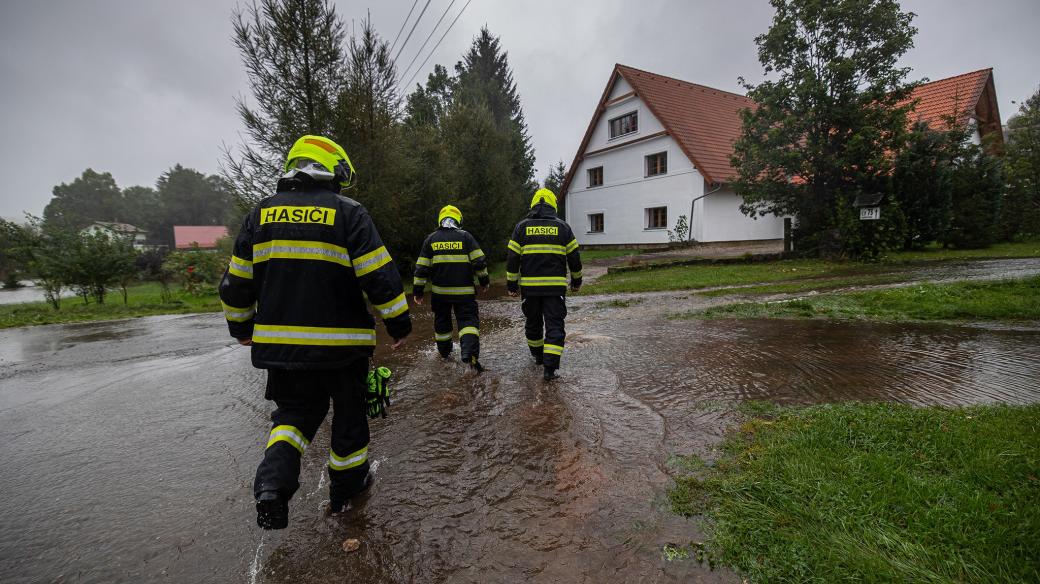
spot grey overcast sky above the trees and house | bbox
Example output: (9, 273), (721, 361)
(0, 0), (1040, 217)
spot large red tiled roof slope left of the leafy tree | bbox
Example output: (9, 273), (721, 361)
(617, 64), (755, 183)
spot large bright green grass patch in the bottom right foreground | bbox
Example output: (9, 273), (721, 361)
(670, 403), (1040, 583)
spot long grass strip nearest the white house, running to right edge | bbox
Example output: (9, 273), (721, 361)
(582, 240), (1040, 294)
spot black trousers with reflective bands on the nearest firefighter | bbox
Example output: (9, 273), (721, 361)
(253, 357), (368, 504)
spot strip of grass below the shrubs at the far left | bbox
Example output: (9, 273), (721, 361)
(0, 283), (220, 328)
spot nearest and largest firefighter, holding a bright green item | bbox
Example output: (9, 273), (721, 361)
(219, 136), (412, 529)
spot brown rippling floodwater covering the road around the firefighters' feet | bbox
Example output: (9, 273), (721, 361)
(0, 274), (1040, 584)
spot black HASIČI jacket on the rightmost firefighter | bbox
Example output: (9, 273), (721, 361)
(505, 203), (581, 296)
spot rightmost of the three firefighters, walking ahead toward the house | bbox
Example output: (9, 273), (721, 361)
(505, 188), (581, 381)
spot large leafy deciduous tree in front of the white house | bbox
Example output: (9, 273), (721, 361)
(732, 0), (916, 256)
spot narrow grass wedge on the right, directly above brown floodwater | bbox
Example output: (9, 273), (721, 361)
(680, 277), (1040, 321)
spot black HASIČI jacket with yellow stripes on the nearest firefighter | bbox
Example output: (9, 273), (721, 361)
(219, 179), (412, 369)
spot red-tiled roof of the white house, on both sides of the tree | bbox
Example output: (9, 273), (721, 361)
(562, 63), (999, 193)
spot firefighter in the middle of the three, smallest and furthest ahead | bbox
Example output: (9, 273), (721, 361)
(412, 205), (489, 372)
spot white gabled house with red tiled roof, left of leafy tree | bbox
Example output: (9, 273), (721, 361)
(561, 64), (783, 245)
